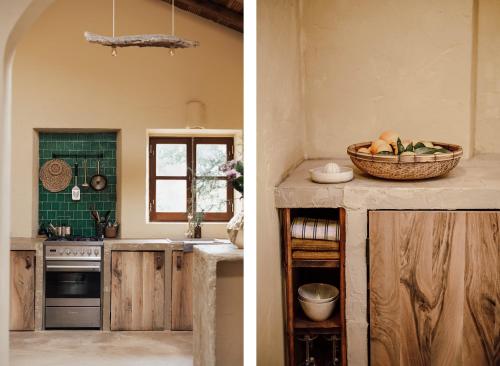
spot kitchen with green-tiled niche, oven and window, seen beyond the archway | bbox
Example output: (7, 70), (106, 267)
(3, 0), (243, 365)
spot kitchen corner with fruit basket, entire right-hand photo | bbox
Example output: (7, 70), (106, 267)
(257, 0), (500, 366)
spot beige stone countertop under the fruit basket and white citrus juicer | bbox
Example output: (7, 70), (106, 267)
(275, 154), (500, 209)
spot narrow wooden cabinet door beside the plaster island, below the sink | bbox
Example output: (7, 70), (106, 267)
(172, 250), (193, 330)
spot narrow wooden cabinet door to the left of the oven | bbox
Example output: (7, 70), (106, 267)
(10, 250), (35, 330)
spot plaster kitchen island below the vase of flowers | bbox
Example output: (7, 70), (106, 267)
(193, 244), (243, 366)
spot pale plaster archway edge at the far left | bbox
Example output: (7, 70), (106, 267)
(0, 0), (53, 365)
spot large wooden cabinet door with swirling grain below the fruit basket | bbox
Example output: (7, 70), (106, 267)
(369, 211), (500, 366)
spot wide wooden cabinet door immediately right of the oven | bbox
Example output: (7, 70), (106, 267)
(111, 251), (165, 330)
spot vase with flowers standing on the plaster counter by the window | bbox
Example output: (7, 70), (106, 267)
(220, 160), (245, 249)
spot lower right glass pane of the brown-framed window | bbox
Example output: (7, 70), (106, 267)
(196, 179), (227, 212)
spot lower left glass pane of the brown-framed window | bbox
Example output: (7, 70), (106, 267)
(156, 180), (187, 212)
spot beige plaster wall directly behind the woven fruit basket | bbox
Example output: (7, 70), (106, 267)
(302, 0), (473, 157)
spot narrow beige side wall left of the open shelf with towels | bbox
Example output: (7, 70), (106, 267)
(257, 0), (305, 366)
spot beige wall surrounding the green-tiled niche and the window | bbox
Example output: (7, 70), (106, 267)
(11, 0), (243, 237)
